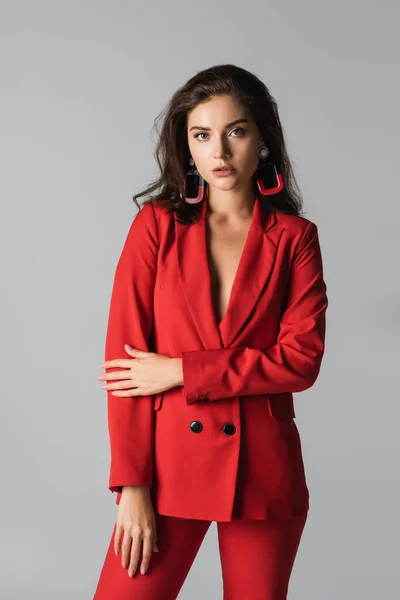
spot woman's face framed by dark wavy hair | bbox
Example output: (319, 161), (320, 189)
(187, 95), (262, 195)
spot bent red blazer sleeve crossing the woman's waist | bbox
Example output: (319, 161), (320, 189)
(182, 221), (328, 405)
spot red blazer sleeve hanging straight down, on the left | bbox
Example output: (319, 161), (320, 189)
(105, 203), (158, 492)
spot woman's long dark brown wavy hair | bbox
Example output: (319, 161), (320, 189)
(133, 64), (303, 223)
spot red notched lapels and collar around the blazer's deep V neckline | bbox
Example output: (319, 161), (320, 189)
(174, 195), (283, 349)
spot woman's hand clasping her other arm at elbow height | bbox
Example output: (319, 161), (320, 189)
(98, 344), (183, 396)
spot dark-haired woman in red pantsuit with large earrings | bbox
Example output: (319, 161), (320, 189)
(94, 65), (328, 600)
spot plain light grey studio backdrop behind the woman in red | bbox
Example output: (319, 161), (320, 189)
(0, 0), (400, 600)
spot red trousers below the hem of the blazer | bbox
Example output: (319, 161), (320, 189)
(93, 513), (307, 600)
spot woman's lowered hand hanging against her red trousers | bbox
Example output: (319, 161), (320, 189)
(114, 485), (159, 577)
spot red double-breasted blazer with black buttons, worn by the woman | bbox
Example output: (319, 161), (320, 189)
(105, 192), (328, 521)
